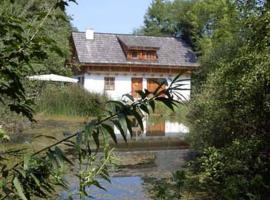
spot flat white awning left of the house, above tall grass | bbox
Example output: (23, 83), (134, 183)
(27, 74), (78, 83)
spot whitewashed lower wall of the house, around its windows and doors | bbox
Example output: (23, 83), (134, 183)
(76, 73), (191, 100)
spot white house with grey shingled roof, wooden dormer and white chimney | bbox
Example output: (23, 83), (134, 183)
(71, 29), (198, 99)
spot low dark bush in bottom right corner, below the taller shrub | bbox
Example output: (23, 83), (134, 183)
(189, 138), (270, 200)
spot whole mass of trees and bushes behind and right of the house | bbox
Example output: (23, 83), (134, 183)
(141, 0), (270, 200)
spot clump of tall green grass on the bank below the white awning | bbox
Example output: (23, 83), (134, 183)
(36, 84), (108, 117)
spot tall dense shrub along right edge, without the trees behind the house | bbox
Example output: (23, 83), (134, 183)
(185, 2), (270, 199)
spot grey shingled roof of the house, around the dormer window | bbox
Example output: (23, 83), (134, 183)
(72, 32), (198, 67)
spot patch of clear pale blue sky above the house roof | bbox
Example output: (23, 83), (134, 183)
(67, 0), (152, 33)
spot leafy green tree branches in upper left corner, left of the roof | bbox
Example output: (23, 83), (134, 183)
(0, 0), (73, 120)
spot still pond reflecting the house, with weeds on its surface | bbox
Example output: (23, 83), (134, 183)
(5, 115), (189, 200)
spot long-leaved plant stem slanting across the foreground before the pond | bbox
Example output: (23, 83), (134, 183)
(0, 76), (186, 199)
